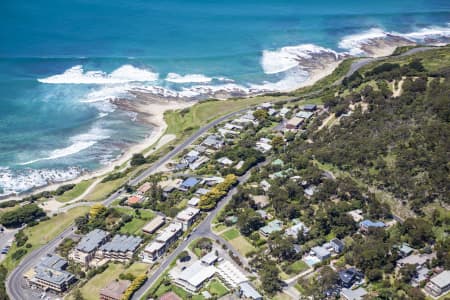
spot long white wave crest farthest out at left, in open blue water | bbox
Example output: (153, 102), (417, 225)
(38, 65), (159, 84)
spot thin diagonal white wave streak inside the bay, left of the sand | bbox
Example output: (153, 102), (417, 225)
(20, 127), (109, 166)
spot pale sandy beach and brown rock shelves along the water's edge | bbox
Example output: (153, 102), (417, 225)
(0, 39), (414, 202)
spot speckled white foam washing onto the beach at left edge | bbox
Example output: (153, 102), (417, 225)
(0, 167), (83, 196)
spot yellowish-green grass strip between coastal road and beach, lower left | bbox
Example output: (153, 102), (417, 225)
(3, 206), (89, 271)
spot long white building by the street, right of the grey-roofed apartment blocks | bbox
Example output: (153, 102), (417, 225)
(140, 223), (183, 263)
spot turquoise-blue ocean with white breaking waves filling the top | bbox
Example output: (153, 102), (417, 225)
(0, 0), (450, 196)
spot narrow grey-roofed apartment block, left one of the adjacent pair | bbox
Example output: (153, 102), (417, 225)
(69, 229), (109, 267)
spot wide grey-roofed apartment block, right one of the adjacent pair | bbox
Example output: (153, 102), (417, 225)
(95, 234), (142, 261)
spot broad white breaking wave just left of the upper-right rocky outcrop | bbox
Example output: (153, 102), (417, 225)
(261, 44), (339, 74)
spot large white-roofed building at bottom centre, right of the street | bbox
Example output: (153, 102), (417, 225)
(169, 260), (216, 292)
